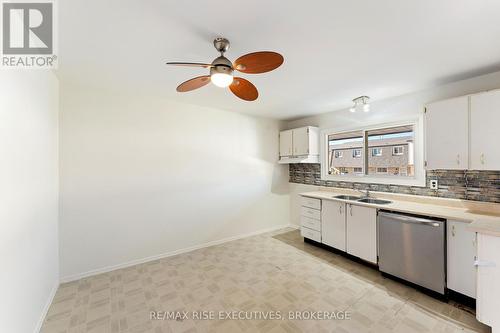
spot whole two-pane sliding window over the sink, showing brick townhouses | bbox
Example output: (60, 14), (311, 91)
(321, 122), (418, 186)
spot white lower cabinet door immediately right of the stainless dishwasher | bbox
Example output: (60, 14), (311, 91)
(447, 220), (476, 298)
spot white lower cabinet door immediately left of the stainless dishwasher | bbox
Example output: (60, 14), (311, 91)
(346, 204), (377, 263)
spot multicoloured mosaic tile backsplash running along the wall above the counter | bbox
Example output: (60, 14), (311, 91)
(289, 163), (500, 203)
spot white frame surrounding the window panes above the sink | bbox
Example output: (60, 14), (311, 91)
(320, 118), (426, 187)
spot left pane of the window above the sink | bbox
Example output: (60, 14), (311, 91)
(327, 131), (364, 175)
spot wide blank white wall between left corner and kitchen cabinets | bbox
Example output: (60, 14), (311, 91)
(60, 85), (289, 280)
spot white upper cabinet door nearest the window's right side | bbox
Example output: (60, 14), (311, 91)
(425, 96), (469, 170)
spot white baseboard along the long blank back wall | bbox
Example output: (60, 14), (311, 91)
(61, 224), (298, 283)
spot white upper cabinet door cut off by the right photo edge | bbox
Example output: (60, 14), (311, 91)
(470, 90), (500, 170)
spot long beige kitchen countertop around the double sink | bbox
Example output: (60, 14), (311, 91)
(300, 189), (500, 237)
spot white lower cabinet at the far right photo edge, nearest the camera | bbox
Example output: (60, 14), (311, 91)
(476, 233), (500, 332)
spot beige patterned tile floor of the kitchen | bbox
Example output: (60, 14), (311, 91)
(42, 229), (488, 333)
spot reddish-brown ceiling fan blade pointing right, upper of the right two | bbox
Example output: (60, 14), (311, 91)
(234, 51), (284, 74)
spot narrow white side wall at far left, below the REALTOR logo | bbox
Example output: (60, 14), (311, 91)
(0, 70), (59, 333)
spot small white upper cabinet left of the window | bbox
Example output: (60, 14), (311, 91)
(280, 126), (319, 163)
